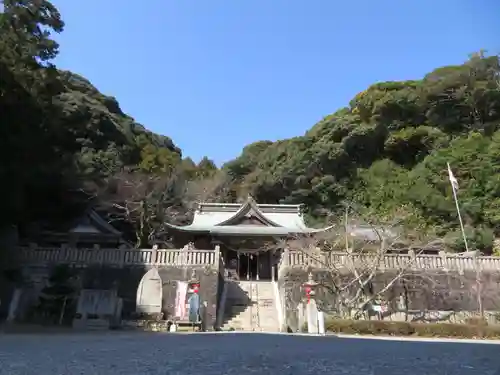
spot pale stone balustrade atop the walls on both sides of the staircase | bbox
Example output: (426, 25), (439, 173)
(18, 246), (500, 271)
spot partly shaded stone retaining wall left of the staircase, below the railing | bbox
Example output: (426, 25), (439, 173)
(16, 266), (219, 328)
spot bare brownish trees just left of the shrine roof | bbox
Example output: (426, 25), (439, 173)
(97, 170), (235, 247)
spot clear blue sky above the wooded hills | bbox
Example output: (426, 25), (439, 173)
(49, 0), (500, 164)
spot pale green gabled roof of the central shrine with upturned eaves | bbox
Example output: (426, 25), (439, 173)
(166, 196), (330, 236)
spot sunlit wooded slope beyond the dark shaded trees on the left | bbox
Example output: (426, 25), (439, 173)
(57, 71), (181, 173)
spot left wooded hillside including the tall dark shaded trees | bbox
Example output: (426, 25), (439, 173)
(0, 0), (186, 228)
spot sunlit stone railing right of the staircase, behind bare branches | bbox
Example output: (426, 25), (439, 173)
(279, 250), (500, 271)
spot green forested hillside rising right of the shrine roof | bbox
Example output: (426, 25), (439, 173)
(224, 53), (500, 253)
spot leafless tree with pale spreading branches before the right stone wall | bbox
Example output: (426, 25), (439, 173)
(280, 209), (444, 318)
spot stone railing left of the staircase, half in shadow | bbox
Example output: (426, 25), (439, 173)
(18, 246), (220, 269)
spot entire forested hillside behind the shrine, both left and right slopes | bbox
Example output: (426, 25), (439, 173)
(0, 0), (500, 254)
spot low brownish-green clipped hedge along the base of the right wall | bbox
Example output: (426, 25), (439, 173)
(314, 320), (500, 339)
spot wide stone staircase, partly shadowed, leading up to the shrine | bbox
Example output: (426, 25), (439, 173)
(222, 281), (279, 332)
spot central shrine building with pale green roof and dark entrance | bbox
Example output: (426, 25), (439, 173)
(166, 196), (330, 280)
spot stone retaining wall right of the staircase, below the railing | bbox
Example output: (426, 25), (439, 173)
(278, 267), (500, 329)
